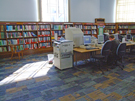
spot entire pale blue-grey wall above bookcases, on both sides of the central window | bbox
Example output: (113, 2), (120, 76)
(0, 0), (116, 22)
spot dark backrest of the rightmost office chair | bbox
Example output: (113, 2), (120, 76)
(116, 43), (126, 56)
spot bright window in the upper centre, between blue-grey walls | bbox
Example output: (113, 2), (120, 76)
(41, 0), (68, 22)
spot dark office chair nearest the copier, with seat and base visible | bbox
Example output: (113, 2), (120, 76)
(92, 40), (112, 74)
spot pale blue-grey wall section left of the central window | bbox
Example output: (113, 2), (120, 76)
(0, 0), (38, 21)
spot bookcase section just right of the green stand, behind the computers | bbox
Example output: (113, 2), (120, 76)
(104, 23), (116, 34)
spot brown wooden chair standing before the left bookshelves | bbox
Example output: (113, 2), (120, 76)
(10, 45), (23, 60)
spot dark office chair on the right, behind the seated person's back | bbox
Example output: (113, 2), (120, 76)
(116, 43), (126, 70)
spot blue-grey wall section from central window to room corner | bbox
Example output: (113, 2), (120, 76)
(70, 0), (100, 22)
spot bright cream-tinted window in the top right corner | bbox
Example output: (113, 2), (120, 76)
(116, 0), (135, 22)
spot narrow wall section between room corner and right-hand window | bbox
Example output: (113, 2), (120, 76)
(100, 0), (116, 23)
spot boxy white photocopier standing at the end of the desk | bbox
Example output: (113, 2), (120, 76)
(53, 40), (73, 70)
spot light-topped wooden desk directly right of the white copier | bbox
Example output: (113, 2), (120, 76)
(73, 47), (101, 66)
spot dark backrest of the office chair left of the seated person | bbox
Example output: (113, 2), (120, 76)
(101, 40), (112, 56)
